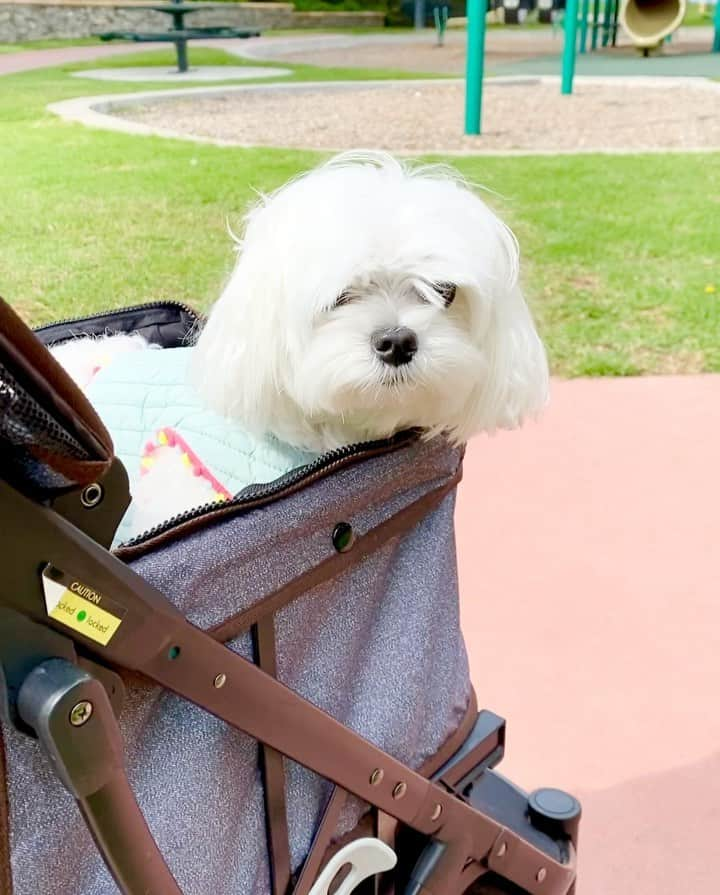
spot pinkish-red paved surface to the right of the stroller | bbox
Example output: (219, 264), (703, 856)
(457, 376), (720, 895)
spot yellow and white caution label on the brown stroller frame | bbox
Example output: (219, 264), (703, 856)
(43, 568), (124, 646)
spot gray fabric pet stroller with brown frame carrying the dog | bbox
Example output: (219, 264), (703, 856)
(0, 302), (580, 895)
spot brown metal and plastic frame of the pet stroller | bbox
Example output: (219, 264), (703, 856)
(0, 303), (580, 895)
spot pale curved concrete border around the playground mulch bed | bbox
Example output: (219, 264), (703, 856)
(47, 75), (720, 157)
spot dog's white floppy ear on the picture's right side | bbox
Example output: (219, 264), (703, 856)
(450, 220), (549, 441)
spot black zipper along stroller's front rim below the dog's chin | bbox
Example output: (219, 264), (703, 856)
(116, 429), (419, 550)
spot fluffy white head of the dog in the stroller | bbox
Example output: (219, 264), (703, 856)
(196, 153), (547, 449)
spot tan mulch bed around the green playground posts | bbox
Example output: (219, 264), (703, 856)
(118, 79), (720, 152)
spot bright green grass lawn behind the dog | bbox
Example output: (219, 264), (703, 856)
(0, 49), (720, 376)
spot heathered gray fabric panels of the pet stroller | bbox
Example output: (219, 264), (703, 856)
(3, 439), (470, 895)
